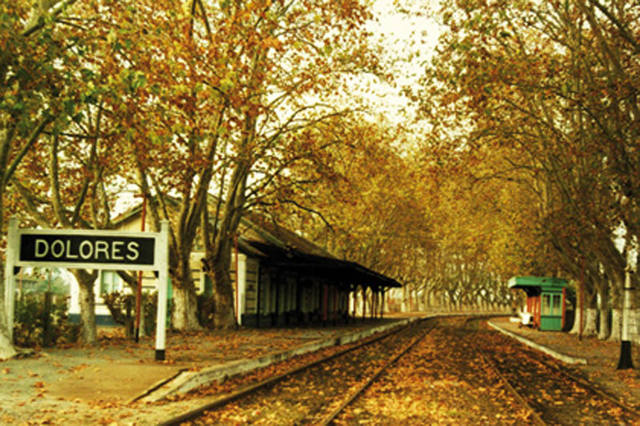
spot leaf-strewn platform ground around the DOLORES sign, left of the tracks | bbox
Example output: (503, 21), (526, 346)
(0, 320), (400, 424)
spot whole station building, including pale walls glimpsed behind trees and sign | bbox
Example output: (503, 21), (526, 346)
(70, 203), (401, 327)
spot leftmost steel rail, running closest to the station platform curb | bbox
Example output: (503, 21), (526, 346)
(159, 319), (427, 426)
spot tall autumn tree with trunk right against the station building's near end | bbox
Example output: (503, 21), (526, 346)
(200, 1), (388, 325)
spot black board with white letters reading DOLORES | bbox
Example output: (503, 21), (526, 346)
(19, 234), (155, 265)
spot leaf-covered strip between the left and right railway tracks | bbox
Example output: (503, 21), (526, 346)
(335, 318), (531, 425)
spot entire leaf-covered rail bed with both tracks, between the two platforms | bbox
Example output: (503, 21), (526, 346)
(164, 318), (640, 425)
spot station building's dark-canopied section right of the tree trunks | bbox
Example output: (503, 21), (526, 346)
(232, 217), (401, 327)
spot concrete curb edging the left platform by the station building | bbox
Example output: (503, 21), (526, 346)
(134, 317), (422, 402)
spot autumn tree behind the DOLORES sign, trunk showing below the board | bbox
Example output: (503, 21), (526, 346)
(6, 3), (134, 343)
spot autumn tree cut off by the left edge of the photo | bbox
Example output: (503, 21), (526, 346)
(0, 0), (92, 358)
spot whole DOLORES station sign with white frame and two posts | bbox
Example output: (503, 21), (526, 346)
(5, 218), (169, 360)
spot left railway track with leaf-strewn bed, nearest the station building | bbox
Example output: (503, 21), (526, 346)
(162, 320), (434, 425)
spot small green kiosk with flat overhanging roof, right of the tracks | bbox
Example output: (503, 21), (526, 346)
(508, 277), (567, 331)
